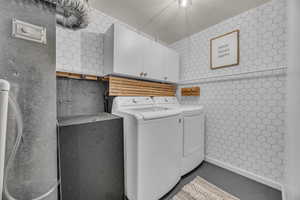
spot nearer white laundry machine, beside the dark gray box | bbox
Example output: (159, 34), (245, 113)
(112, 97), (182, 200)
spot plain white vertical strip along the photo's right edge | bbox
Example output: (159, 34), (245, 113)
(284, 0), (300, 200)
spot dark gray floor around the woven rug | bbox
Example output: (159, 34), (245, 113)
(161, 162), (282, 200)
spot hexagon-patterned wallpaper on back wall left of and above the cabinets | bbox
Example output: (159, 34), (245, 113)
(56, 9), (155, 76)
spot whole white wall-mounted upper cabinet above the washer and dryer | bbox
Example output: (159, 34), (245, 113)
(104, 25), (179, 82)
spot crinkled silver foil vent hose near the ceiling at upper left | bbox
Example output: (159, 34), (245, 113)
(15, 0), (90, 29)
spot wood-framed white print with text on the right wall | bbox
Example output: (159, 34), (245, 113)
(210, 30), (240, 69)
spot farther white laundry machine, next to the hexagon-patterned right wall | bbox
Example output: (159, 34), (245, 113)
(154, 97), (205, 175)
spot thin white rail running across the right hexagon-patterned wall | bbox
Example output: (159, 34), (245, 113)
(179, 67), (287, 85)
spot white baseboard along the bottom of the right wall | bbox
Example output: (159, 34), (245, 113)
(205, 156), (282, 191)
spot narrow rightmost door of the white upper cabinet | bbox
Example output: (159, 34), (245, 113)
(164, 48), (179, 82)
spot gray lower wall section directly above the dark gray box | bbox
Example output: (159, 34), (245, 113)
(57, 78), (105, 117)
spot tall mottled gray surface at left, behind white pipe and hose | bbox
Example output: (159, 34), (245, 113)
(0, 0), (57, 200)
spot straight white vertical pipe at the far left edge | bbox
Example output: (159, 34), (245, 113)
(0, 79), (9, 200)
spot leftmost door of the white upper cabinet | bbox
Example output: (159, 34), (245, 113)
(113, 26), (145, 76)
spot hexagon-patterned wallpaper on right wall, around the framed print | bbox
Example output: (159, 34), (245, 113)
(172, 0), (286, 184)
